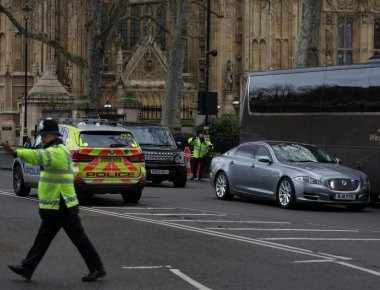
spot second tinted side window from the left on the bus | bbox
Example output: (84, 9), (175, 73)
(284, 71), (325, 113)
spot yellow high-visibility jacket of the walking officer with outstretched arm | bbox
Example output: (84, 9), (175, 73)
(17, 144), (79, 210)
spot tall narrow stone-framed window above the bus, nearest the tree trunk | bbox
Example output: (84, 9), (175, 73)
(337, 17), (353, 64)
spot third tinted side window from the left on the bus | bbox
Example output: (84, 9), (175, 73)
(322, 68), (369, 112)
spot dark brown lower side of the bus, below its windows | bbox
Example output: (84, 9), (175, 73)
(241, 112), (380, 195)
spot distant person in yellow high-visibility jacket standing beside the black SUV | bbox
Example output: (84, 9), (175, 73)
(188, 130), (214, 180)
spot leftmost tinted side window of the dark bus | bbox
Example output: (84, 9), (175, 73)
(249, 75), (284, 113)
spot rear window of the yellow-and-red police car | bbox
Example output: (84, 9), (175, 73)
(78, 131), (137, 148)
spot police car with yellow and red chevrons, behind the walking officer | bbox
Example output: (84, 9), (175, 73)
(13, 120), (146, 203)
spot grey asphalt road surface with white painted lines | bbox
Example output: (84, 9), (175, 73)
(0, 171), (380, 289)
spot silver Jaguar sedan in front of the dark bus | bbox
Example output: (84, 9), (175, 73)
(210, 141), (370, 211)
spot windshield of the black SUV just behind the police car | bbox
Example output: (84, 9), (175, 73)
(129, 127), (176, 146)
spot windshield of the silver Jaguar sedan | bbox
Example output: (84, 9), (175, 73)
(271, 143), (336, 163)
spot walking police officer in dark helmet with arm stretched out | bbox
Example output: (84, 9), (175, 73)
(2, 119), (106, 282)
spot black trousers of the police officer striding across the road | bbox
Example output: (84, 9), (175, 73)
(22, 204), (103, 273)
